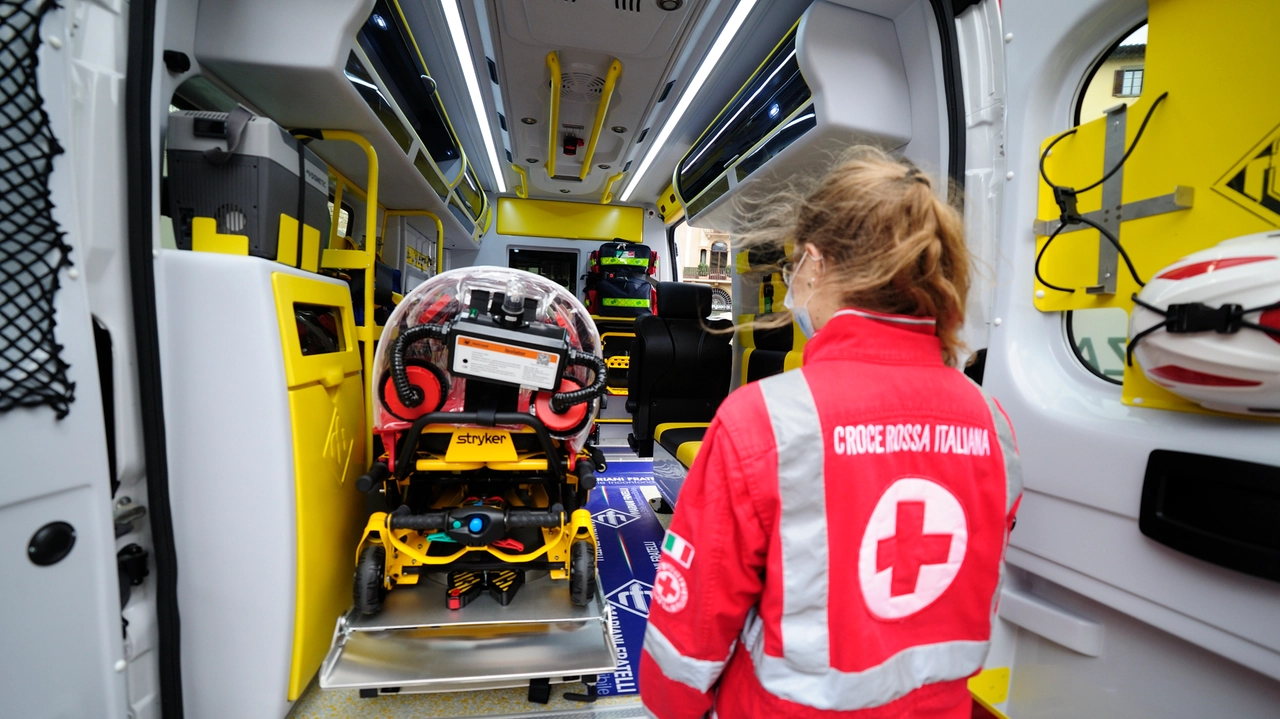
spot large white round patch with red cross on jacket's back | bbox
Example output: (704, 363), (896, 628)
(858, 477), (969, 619)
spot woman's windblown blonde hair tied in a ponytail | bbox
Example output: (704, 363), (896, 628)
(735, 147), (970, 366)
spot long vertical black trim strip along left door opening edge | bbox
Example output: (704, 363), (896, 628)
(124, 0), (183, 719)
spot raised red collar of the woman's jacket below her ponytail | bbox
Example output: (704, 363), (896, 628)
(804, 307), (942, 365)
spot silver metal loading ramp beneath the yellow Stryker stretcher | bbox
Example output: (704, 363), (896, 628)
(319, 572), (617, 696)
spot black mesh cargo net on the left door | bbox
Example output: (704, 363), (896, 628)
(0, 0), (76, 418)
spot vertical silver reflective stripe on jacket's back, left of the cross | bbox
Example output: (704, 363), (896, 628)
(760, 370), (831, 672)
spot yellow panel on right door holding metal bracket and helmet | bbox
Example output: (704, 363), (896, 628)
(1034, 0), (1280, 412)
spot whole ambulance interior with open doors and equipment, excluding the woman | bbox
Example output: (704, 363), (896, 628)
(0, 0), (1280, 719)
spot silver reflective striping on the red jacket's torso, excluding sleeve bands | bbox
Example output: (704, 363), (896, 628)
(742, 370), (993, 711)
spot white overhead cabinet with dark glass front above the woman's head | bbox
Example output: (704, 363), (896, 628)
(672, 0), (913, 230)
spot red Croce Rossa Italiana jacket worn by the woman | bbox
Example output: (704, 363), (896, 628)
(640, 310), (1021, 719)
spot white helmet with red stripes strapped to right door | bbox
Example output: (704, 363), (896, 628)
(1129, 233), (1280, 417)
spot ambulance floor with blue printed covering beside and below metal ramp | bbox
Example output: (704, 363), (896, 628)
(289, 438), (671, 719)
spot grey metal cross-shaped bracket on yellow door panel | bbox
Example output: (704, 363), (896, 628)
(1033, 105), (1196, 294)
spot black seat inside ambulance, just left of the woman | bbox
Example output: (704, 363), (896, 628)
(627, 283), (733, 457)
